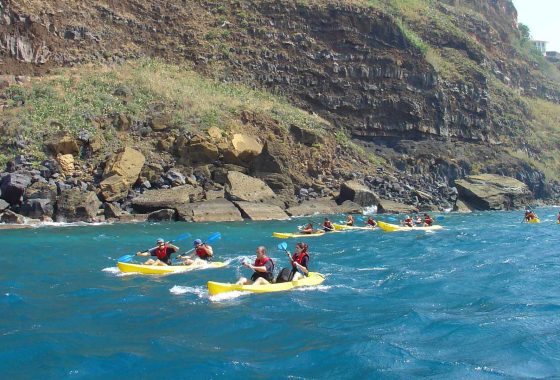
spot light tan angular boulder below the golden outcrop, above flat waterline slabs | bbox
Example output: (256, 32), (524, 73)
(225, 171), (274, 202)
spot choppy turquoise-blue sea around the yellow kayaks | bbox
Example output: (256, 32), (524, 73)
(0, 208), (560, 379)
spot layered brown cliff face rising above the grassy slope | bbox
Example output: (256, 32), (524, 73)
(0, 0), (560, 200)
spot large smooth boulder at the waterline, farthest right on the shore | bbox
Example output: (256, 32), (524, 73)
(455, 174), (532, 210)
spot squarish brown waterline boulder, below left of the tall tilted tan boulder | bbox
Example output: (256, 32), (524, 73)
(56, 188), (101, 222)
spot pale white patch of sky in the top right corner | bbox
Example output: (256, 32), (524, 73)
(513, 0), (560, 52)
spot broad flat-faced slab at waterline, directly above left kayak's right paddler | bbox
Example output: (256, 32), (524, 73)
(177, 199), (243, 222)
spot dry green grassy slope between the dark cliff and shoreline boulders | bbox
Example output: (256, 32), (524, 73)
(0, 59), (328, 159)
